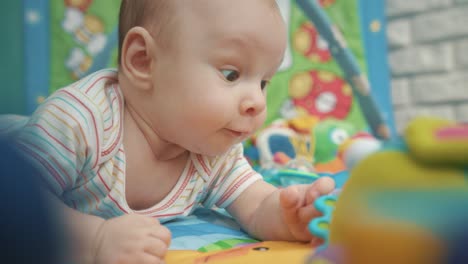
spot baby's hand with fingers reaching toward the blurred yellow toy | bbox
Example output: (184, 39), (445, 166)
(280, 177), (335, 246)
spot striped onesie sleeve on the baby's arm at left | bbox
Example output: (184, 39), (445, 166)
(14, 88), (100, 197)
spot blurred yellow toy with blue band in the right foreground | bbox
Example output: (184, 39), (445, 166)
(330, 118), (468, 264)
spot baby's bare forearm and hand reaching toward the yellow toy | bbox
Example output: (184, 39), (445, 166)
(227, 177), (334, 241)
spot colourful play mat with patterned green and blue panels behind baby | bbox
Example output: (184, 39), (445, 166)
(4, 0), (394, 263)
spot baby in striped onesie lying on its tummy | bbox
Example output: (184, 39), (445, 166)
(15, 0), (334, 264)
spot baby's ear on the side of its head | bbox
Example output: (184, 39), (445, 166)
(120, 27), (154, 89)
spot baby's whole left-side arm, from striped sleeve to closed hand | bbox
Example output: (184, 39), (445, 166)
(14, 87), (170, 264)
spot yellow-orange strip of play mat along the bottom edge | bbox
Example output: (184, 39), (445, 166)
(165, 241), (311, 264)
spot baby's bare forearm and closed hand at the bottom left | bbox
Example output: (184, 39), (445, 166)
(50, 194), (171, 264)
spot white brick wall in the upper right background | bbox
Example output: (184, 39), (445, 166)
(386, 0), (468, 131)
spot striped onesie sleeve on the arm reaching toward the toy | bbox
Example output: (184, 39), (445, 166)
(203, 144), (263, 208)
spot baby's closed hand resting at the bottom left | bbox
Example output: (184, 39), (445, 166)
(93, 214), (171, 264)
